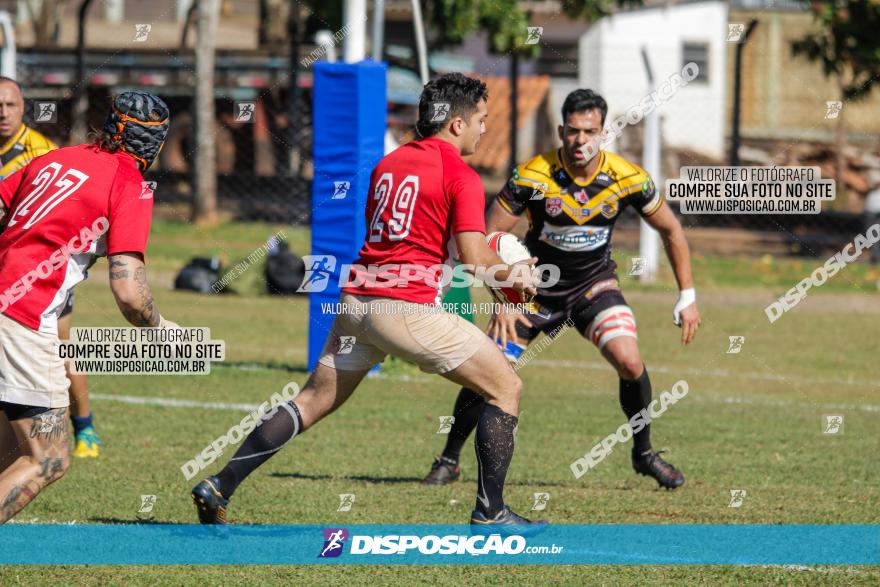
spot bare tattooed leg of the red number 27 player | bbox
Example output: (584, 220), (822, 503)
(0, 408), (70, 524)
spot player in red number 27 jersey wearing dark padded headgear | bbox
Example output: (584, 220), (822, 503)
(0, 92), (175, 523)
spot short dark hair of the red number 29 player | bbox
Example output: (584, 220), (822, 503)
(416, 73), (489, 138)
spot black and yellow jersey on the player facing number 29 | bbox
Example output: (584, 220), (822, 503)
(497, 149), (663, 291)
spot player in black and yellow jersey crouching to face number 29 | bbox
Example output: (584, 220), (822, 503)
(424, 90), (700, 489)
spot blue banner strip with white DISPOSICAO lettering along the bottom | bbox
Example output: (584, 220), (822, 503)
(0, 524), (880, 565)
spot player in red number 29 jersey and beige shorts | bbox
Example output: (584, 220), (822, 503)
(192, 74), (546, 534)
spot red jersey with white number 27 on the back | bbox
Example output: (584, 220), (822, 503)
(0, 145), (153, 333)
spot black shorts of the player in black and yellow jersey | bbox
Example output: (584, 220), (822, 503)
(516, 273), (629, 343)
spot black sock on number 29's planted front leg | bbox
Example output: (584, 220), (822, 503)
(476, 404), (519, 518)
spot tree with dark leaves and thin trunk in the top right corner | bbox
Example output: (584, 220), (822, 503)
(791, 0), (880, 211)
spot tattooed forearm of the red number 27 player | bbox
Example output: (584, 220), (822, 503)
(108, 253), (162, 326)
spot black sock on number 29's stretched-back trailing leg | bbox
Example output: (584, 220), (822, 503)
(217, 402), (302, 499)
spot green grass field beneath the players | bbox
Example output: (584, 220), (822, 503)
(0, 221), (880, 585)
